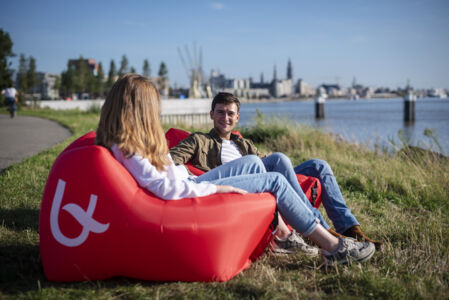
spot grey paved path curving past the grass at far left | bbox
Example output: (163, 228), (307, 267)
(0, 114), (71, 170)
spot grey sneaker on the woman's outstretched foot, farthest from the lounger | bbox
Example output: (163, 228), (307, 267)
(321, 238), (376, 266)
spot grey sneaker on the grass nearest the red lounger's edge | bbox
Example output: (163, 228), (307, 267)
(270, 230), (319, 256)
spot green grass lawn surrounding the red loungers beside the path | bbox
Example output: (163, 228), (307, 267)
(0, 110), (449, 299)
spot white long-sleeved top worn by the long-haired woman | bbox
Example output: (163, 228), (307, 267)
(111, 145), (217, 200)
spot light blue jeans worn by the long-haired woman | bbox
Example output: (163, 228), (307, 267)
(194, 155), (317, 236)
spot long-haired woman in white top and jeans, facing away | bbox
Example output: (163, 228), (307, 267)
(96, 74), (375, 264)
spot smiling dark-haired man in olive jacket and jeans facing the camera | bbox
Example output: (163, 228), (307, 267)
(170, 93), (382, 255)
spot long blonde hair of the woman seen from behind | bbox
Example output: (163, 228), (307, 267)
(95, 73), (170, 171)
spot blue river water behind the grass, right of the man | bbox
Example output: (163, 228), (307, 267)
(239, 98), (449, 155)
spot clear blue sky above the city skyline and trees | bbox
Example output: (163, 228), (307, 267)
(0, 0), (449, 88)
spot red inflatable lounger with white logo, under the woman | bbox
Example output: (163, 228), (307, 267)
(39, 132), (276, 281)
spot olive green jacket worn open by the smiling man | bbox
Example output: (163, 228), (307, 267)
(170, 129), (265, 172)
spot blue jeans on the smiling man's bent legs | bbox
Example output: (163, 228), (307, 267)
(262, 152), (359, 233)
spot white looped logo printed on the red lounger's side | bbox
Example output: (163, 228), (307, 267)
(50, 179), (109, 247)
